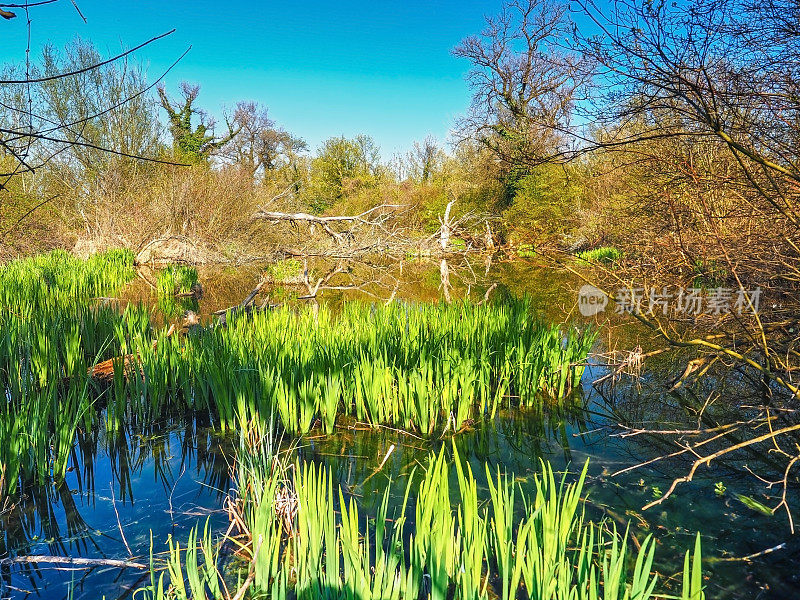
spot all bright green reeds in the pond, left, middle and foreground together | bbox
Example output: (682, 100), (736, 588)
(0, 251), (703, 600)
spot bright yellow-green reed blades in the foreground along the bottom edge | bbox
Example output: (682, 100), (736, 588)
(141, 436), (704, 600)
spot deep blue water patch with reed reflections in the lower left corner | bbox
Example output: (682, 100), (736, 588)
(0, 418), (232, 598)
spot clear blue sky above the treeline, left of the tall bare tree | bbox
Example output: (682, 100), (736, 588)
(0, 0), (501, 158)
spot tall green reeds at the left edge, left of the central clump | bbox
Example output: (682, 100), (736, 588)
(0, 250), (136, 499)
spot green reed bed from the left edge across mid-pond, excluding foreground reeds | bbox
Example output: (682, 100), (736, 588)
(0, 251), (595, 494)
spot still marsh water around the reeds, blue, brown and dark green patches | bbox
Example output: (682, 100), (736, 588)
(0, 260), (800, 599)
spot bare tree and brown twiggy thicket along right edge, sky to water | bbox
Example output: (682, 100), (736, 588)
(557, 0), (800, 520)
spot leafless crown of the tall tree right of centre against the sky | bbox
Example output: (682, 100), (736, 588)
(453, 0), (585, 165)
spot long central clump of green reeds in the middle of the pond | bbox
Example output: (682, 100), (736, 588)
(128, 300), (595, 434)
